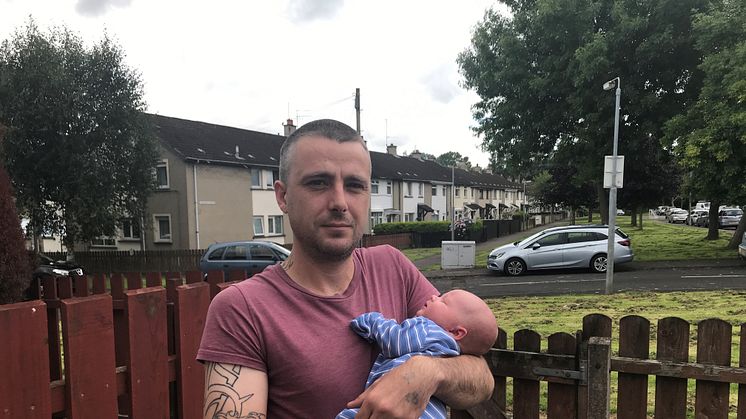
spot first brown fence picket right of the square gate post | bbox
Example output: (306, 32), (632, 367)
(617, 316), (650, 419)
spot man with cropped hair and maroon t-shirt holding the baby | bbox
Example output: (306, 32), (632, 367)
(198, 120), (494, 418)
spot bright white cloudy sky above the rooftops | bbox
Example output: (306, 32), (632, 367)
(0, 0), (503, 167)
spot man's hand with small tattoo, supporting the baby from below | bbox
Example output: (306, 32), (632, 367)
(347, 356), (440, 419)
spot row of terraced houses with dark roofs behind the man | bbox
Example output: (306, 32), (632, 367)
(101, 115), (526, 250)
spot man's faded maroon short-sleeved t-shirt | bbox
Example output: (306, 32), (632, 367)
(197, 246), (440, 418)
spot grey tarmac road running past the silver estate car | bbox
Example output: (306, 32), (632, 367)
(429, 261), (746, 298)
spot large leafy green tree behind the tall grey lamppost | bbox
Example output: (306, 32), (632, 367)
(458, 0), (709, 226)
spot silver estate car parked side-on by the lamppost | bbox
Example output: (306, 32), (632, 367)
(487, 225), (634, 276)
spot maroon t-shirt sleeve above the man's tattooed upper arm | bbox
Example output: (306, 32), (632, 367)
(197, 286), (267, 372)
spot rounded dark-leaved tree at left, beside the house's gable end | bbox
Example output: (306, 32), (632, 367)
(0, 20), (158, 250)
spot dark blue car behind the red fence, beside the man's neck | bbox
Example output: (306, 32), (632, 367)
(199, 240), (290, 276)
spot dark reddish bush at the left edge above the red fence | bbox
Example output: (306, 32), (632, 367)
(0, 166), (31, 304)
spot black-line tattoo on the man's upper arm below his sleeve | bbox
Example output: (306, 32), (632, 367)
(204, 363), (267, 419)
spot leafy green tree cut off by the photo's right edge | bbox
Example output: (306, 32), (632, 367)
(666, 0), (746, 244)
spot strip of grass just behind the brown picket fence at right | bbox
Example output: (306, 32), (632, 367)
(486, 291), (746, 418)
